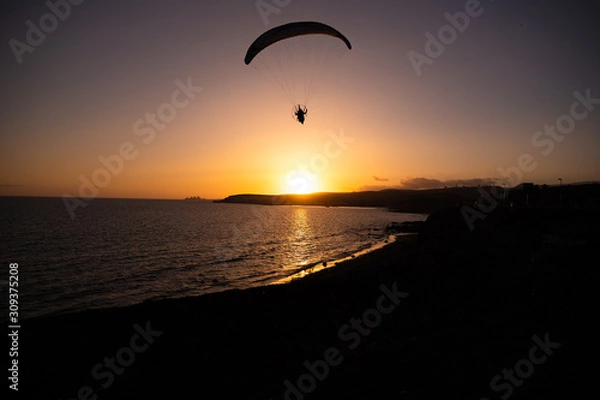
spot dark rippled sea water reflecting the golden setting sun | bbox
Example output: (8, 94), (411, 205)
(0, 197), (425, 319)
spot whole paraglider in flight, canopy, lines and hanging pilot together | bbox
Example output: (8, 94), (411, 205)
(244, 21), (352, 124)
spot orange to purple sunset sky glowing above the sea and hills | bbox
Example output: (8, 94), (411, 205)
(0, 1), (600, 198)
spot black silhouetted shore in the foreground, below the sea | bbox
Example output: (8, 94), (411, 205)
(11, 208), (600, 400)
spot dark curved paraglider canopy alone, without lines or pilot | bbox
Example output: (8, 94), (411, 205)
(244, 22), (352, 65)
